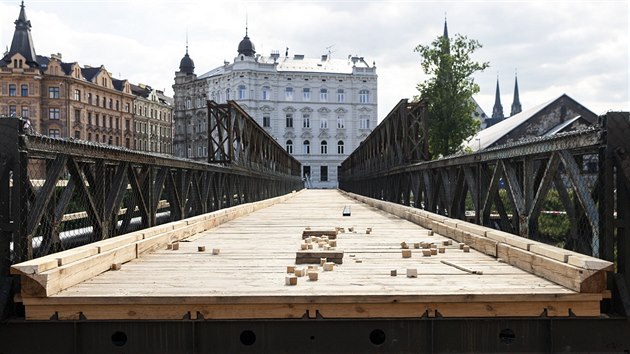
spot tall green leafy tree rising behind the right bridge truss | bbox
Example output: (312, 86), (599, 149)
(415, 34), (489, 159)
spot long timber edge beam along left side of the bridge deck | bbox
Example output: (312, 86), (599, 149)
(11, 191), (296, 298)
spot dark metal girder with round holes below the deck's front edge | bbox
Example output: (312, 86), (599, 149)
(0, 318), (630, 354)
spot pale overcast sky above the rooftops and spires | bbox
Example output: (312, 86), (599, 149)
(0, 0), (630, 121)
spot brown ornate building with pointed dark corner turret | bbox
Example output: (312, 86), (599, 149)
(0, 3), (172, 152)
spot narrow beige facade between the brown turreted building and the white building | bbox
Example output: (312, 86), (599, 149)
(131, 84), (173, 155)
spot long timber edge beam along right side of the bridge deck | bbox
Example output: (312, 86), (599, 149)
(342, 191), (614, 293)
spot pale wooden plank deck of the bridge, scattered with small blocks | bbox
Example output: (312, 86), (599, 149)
(14, 190), (610, 320)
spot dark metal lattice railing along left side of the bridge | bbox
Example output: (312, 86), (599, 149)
(0, 112), (303, 284)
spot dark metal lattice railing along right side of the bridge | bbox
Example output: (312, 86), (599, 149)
(340, 108), (630, 314)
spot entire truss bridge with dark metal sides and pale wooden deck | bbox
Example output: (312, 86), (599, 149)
(0, 100), (630, 353)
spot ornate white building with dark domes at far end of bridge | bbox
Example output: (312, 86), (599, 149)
(173, 31), (377, 188)
